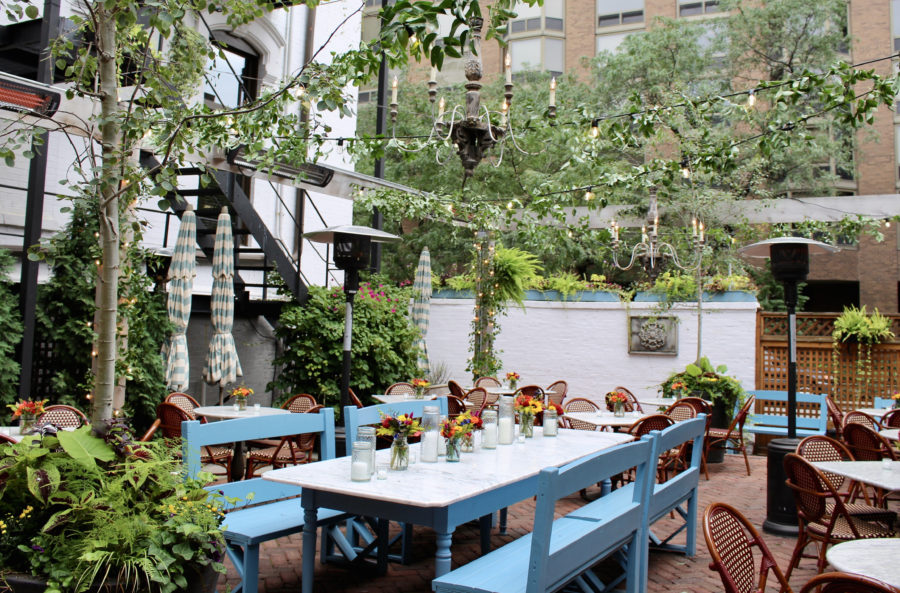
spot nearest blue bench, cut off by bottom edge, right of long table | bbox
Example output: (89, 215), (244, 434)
(431, 435), (656, 593)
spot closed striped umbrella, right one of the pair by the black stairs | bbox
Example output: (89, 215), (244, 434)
(203, 207), (244, 404)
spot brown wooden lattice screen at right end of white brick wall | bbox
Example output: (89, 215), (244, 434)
(756, 312), (900, 411)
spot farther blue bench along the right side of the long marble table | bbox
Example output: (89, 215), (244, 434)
(568, 414), (706, 590)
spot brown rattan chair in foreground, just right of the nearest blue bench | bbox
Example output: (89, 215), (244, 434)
(703, 502), (791, 593)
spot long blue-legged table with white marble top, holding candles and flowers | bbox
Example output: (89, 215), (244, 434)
(263, 427), (633, 593)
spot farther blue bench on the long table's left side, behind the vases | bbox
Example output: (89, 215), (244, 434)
(340, 397), (447, 564)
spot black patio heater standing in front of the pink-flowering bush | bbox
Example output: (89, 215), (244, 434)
(303, 224), (400, 426)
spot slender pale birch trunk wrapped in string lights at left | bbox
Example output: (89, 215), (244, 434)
(91, 2), (122, 428)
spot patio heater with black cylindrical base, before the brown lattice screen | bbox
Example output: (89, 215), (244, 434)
(738, 237), (839, 537)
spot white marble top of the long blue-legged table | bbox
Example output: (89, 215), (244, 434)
(262, 427), (633, 507)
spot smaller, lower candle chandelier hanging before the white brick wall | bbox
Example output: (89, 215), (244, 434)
(611, 188), (706, 282)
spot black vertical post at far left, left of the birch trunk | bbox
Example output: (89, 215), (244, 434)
(19, 0), (59, 399)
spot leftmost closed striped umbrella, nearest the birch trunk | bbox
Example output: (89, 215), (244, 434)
(162, 204), (197, 391)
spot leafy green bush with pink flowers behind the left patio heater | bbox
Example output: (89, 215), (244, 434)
(268, 276), (420, 405)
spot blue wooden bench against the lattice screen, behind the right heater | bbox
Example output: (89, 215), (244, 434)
(744, 391), (828, 438)
